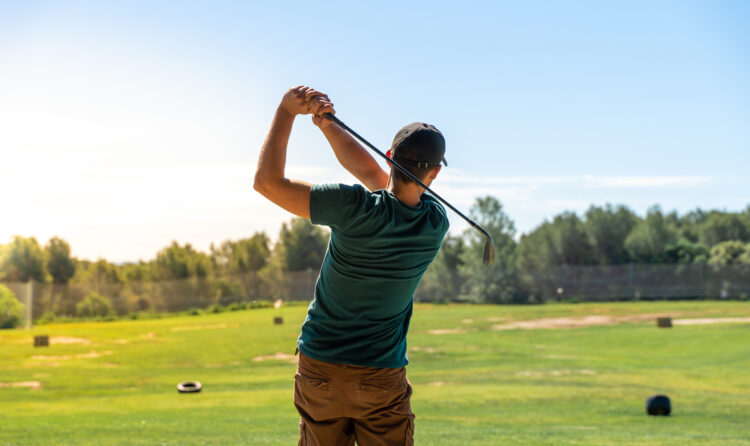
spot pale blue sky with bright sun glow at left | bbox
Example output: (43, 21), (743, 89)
(0, 0), (750, 262)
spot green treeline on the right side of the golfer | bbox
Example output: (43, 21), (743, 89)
(417, 197), (750, 303)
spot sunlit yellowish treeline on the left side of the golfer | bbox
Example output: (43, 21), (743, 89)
(0, 219), (328, 320)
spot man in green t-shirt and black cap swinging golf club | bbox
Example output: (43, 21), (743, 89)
(255, 86), (448, 446)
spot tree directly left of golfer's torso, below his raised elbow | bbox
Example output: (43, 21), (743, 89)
(275, 218), (328, 271)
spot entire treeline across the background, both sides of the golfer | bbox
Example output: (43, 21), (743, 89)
(0, 196), (750, 319)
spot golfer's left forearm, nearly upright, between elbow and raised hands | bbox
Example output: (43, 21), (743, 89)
(255, 107), (294, 187)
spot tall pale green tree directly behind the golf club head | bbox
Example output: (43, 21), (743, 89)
(459, 196), (519, 303)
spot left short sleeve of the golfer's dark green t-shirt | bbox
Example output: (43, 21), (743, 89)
(310, 184), (365, 229)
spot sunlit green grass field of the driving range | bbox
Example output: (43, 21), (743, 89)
(0, 302), (750, 446)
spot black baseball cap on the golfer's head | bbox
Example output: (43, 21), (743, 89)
(391, 122), (448, 168)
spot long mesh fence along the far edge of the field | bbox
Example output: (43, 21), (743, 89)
(5, 264), (750, 320)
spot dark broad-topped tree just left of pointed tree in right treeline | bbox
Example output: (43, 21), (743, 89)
(584, 204), (639, 265)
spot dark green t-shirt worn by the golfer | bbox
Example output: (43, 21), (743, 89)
(297, 184), (448, 368)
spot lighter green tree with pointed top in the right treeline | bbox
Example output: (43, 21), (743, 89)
(625, 206), (677, 263)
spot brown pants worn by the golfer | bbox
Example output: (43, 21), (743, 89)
(294, 353), (414, 446)
